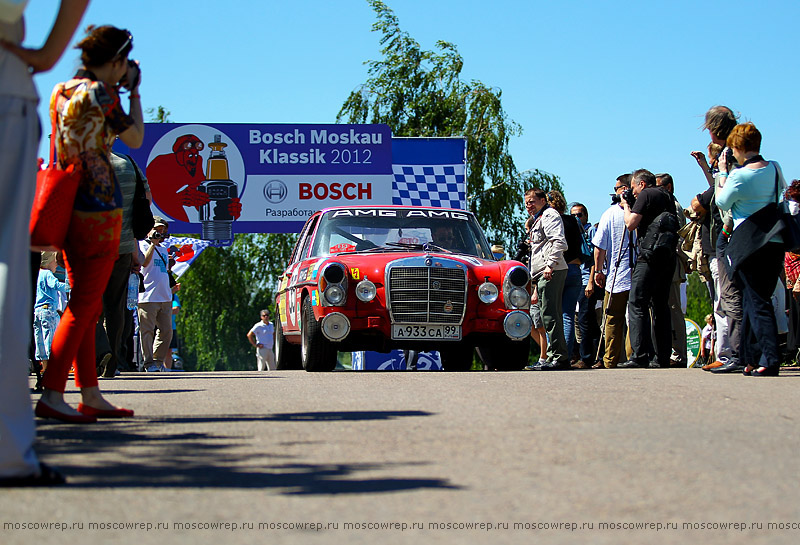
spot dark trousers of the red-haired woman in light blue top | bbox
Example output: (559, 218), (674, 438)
(734, 242), (784, 367)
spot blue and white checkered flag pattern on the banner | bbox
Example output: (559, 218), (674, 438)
(392, 165), (467, 210)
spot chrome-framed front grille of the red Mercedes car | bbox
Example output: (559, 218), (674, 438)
(388, 267), (467, 324)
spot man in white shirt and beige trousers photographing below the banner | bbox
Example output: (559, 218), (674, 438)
(139, 216), (179, 372)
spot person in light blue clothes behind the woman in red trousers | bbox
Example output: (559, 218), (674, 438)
(33, 252), (69, 371)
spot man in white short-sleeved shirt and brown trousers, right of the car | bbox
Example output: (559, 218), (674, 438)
(592, 174), (636, 369)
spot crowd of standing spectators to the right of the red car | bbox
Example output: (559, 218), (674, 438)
(521, 106), (800, 376)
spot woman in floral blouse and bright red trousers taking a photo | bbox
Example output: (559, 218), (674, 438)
(35, 25), (144, 423)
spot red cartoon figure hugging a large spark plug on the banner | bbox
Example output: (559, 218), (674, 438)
(147, 134), (242, 240)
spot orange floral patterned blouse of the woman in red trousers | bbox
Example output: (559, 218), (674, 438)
(50, 70), (134, 217)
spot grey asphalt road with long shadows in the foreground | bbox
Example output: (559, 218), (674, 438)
(0, 369), (800, 545)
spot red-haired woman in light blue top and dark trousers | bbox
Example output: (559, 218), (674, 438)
(716, 123), (785, 377)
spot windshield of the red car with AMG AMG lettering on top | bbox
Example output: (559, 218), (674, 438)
(311, 208), (494, 260)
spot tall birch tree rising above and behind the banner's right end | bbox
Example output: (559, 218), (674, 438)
(336, 0), (560, 248)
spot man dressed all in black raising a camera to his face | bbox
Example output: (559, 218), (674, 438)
(618, 169), (678, 368)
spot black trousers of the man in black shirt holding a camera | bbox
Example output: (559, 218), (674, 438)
(628, 252), (677, 367)
